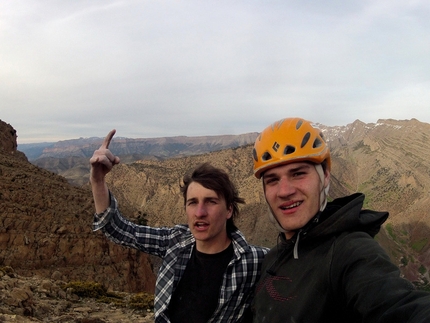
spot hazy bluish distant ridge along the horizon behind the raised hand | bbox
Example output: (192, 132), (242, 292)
(18, 133), (257, 186)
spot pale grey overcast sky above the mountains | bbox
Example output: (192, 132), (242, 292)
(0, 0), (430, 144)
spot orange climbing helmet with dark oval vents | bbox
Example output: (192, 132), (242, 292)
(252, 118), (331, 179)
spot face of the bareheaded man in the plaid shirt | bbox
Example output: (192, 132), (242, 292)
(185, 182), (232, 253)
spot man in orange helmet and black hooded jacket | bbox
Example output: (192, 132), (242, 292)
(253, 118), (430, 323)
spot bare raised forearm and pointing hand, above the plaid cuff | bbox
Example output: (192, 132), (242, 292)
(90, 129), (119, 213)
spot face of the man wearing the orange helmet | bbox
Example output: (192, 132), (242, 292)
(263, 162), (329, 239)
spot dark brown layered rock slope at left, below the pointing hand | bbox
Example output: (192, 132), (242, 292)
(0, 121), (155, 292)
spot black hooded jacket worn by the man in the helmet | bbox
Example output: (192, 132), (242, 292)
(253, 193), (430, 323)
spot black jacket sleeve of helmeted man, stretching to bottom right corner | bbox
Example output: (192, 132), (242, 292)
(330, 232), (430, 323)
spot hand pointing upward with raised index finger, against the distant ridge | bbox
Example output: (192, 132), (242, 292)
(90, 129), (120, 182)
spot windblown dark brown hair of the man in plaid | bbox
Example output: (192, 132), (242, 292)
(180, 163), (245, 232)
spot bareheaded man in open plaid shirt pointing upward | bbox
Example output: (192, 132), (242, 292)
(90, 130), (268, 323)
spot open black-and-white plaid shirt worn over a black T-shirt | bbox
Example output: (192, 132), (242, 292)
(93, 195), (269, 323)
